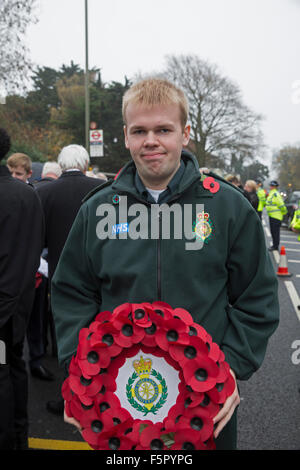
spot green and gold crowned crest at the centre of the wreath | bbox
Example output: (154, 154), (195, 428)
(126, 356), (168, 416)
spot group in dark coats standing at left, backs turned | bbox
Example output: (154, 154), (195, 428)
(0, 129), (105, 449)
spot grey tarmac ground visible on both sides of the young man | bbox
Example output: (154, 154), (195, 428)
(25, 214), (300, 450)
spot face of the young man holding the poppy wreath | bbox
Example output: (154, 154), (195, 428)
(124, 103), (190, 189)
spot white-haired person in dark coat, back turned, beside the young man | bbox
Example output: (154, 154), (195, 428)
(36, 145), (105, 414)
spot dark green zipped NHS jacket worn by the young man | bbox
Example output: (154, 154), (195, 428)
(52, 152), (279, 448)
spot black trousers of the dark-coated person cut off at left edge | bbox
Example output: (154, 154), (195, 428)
(0, 321), (28, 450)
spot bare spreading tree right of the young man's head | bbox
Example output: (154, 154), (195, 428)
(164, 55), (263, 168)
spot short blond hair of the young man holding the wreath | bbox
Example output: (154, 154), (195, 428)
(122, 78), (189, 129)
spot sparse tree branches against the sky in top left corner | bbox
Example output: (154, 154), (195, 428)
(0, 0), (36, 92)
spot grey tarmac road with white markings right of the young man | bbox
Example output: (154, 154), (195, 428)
(238, 213), (300, 450)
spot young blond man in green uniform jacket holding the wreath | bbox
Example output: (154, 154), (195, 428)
(52, 79), (279, 449)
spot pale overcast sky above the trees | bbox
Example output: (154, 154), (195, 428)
(27, 0), (300, 165)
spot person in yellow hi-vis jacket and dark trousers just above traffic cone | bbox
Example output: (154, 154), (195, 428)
(266, 180), (287, 251)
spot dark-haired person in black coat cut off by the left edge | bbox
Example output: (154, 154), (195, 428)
(0, 129), (44, 449)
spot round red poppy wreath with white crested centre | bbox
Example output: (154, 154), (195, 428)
(62, 302), (235, 450)
